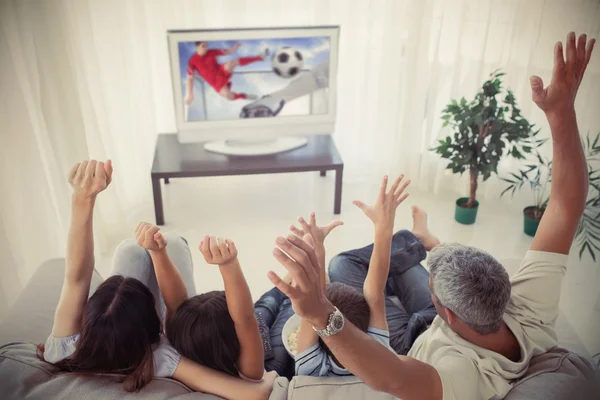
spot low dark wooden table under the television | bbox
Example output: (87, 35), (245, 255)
(151, 134), (344, 225)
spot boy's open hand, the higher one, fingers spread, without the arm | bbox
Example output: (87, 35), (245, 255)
(352, 175), (410, 232)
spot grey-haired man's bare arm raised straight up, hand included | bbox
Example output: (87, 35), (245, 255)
(531, 32), (595, 254)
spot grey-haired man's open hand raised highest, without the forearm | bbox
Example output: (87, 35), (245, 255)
(530, 32), (596, 118)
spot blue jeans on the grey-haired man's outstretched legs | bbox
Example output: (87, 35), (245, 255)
(329, 230), (437, 355)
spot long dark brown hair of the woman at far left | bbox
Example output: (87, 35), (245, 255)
(38, 275), (161, 392)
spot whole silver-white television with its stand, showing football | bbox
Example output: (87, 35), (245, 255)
(168, 26), (339, 155)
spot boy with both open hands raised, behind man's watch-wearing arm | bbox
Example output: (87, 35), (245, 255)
(290, 175), (410, 376)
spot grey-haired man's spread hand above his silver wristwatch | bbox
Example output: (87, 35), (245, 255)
(267, 235), (334, 328)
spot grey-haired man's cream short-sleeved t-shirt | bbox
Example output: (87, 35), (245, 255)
(408, 251), (568, 400)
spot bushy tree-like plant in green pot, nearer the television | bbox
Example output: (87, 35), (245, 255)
(432, 71), (533, 224)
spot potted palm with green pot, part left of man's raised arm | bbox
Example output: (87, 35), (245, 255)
(500, 143), (552, 236)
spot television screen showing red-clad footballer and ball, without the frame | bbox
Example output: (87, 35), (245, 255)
(178, 37), (330, 121)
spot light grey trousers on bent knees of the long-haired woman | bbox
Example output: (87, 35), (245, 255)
(111, 232), (196, 326)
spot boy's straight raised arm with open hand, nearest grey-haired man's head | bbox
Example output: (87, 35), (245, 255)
(354, 175), (410, 330)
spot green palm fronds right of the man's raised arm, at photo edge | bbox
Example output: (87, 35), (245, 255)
(576, 132), (600, 262)
